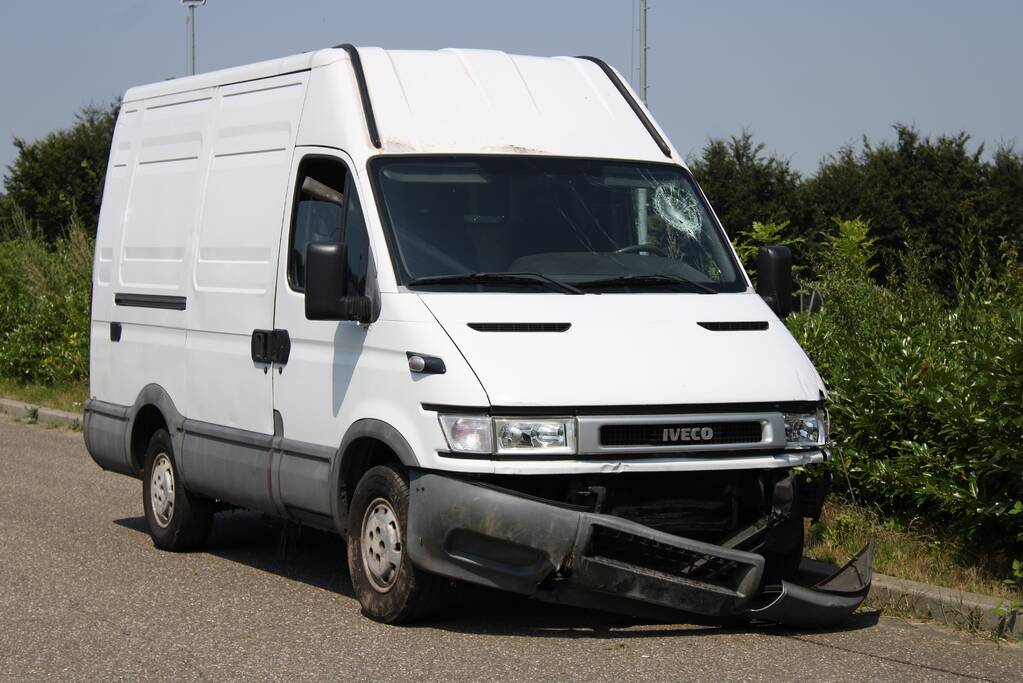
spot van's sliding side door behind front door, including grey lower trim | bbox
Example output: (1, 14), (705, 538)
(182, 73), (308, 511)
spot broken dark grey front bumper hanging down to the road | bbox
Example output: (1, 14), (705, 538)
(407, 470), (873, 626)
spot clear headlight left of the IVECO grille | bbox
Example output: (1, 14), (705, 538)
(440, 415), (576, 455)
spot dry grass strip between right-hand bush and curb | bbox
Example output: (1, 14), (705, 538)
(806, 501), (1023, 601)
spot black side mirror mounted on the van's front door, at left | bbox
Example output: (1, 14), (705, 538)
(306, 242), (371, 323)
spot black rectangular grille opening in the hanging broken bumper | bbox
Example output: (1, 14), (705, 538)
(585, 525), (749, 590)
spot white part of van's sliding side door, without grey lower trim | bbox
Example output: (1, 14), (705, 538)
(186, 73), (307, 434)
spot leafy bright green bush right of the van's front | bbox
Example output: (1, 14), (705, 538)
(789, 221), (1023, 551)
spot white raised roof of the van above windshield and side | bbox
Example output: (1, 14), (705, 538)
(124, 47), (680, 163)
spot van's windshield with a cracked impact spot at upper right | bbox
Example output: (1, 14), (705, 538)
(370, 156), (746, 292)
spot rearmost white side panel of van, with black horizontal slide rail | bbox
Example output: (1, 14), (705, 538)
(91, 90), (213, 406)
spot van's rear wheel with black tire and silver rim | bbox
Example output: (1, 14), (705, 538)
(142, 429), (214, 552)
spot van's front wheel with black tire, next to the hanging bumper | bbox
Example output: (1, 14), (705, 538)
(348, 465), (450, 624)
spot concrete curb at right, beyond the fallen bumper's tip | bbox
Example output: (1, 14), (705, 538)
(866, 574), (1023, 640)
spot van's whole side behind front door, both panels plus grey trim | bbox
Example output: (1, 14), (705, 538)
(86, 73), (308, 511)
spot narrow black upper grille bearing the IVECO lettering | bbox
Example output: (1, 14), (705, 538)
(601, 420), (763, 446)
